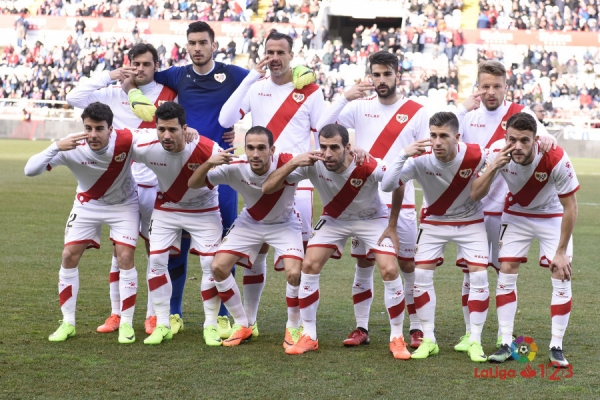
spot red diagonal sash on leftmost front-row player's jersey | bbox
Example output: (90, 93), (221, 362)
(77, 129), (133, 204)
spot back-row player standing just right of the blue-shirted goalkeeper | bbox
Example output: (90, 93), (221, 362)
(219, 31), (324, 332)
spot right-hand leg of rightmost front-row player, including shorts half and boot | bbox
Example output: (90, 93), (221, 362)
(534, 218), (573, 368)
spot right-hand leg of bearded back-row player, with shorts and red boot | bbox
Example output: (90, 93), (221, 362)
(397, 208), (423, 349)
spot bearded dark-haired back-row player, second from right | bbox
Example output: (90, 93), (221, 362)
(319, 51), (429, 348)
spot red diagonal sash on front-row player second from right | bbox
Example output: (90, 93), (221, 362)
(423, 144), (482, 216)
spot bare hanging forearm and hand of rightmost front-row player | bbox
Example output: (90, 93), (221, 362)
(550, 193), (577, 281)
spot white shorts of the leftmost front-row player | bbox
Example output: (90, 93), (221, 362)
(65, 203), (140, 249)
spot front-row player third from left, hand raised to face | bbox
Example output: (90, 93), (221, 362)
(188, 126), (304, 349)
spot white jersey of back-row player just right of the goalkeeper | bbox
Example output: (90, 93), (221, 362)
(219, 70), (324, 153)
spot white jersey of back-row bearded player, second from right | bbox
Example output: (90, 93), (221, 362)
(318, 94), (429, 208)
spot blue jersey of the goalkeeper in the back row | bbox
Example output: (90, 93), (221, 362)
(154, 61), (249, 149)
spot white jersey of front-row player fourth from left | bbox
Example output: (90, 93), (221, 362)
(286, 158), (388, 220)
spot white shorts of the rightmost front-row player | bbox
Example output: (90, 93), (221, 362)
(498, 213), (573, 268)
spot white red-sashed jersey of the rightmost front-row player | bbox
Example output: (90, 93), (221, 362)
(486, 139), (579, 218)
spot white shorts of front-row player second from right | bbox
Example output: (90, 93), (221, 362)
(415, 222), (489, 267)
